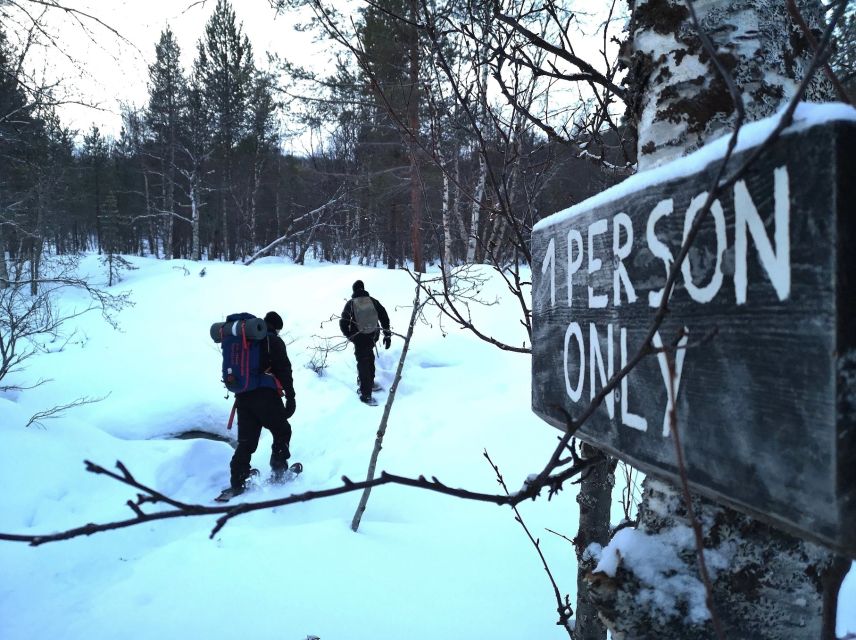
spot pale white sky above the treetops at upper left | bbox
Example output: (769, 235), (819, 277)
(4, 0), (329, 142)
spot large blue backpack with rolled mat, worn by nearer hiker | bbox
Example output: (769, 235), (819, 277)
(211, 313), (277, 394)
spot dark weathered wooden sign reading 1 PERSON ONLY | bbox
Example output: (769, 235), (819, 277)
(532, 120), (856, 557)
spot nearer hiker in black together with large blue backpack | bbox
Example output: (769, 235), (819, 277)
(212, 311), (296, 499)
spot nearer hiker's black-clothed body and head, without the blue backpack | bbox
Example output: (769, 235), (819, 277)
(229, 311), (296, 494)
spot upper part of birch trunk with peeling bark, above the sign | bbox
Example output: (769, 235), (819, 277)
(625, 0), (831, 171)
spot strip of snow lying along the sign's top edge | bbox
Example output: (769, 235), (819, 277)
(533, 102), (856, 230)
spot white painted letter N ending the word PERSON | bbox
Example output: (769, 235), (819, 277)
(734, 167), (791, 304)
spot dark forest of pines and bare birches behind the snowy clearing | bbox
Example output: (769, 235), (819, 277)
(0, 0), (627, 280)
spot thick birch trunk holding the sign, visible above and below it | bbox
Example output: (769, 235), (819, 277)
(589, 0), (837, 640)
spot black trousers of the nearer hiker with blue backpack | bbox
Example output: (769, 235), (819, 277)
(229, 387), (291, 488)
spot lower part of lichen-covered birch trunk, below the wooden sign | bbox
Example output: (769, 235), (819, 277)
(589, 477), (833, 640)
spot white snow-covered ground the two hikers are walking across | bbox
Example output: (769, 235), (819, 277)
(0, 257), (856, 640)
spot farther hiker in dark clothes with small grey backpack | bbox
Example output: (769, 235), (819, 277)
(339, 280), (392, 404)
